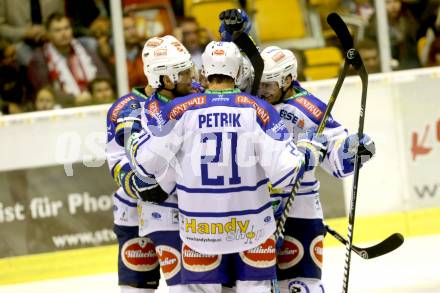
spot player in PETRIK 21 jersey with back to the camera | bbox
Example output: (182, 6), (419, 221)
(129, 42), (326, 293)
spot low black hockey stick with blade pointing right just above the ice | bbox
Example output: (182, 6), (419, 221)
(325, 225), (404, 259)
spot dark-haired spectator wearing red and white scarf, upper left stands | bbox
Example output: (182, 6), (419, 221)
(28, 13), (110, 107)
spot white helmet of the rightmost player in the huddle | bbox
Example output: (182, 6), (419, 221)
(261, 46), (298, 88)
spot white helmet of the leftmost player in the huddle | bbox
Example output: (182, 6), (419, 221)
(142, 36), (192, 89)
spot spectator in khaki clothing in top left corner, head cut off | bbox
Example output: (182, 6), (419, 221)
(0, 0), (64, 66)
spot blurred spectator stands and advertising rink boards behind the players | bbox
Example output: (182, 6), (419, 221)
(0, 0), (440, 290)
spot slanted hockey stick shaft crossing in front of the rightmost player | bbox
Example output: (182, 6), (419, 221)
(274, 61), (349, 241)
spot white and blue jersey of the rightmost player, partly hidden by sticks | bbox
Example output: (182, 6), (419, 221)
(271, 82), (352, 219)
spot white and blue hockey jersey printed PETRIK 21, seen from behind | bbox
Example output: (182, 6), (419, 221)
(132, 91), (304, 254)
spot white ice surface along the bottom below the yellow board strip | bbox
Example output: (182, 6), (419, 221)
(0, 235), (440, 293)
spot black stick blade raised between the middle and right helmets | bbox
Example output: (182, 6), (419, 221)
(232, 32), (264, 96)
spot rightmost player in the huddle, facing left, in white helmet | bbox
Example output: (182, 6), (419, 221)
(259, 46), (375, 293)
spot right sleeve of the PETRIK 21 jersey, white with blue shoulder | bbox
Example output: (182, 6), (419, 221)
(251, 95), (304, 188)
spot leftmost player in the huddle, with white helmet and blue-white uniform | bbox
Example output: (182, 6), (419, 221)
(106, 36), (202, 293)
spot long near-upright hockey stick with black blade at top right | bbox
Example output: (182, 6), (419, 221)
(327, 13), (368, 293)
